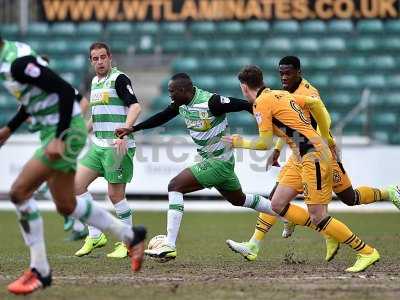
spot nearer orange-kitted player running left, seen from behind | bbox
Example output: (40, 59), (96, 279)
(224, 66), (380, 272)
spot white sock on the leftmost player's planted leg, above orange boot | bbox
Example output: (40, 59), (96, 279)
(16, 198), (50, 276)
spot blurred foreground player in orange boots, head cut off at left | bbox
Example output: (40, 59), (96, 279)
(0, 37), (146, 294)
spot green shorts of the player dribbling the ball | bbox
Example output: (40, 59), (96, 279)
(190, 158), (241, 192)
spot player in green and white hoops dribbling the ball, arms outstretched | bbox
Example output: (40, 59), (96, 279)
(117, 73), (284, 260)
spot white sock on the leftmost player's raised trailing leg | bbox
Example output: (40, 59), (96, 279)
(72, 192), (133, 244)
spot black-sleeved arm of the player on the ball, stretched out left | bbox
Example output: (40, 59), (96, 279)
(115, 103), (179, 138)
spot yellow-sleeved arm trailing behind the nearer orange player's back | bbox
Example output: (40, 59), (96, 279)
(295, 95), (335, 146)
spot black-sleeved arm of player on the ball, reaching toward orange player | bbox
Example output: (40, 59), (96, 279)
(208, 94), (253, 116)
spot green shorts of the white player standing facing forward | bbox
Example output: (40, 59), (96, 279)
(79, 145), (135, 183)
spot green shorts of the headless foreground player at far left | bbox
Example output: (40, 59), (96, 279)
(33, 116), (87, 173)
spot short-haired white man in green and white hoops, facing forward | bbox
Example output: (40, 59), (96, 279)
(75, 43), (140, 258)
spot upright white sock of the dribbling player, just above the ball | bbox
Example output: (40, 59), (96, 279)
(167, 192), (183, 248)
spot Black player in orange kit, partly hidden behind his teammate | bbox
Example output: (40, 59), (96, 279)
(227, 56), (400, 261)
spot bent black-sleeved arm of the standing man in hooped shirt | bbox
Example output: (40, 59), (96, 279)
(115, 74), (141, 128)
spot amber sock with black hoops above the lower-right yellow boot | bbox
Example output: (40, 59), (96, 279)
(317, 216), (374, 254)
